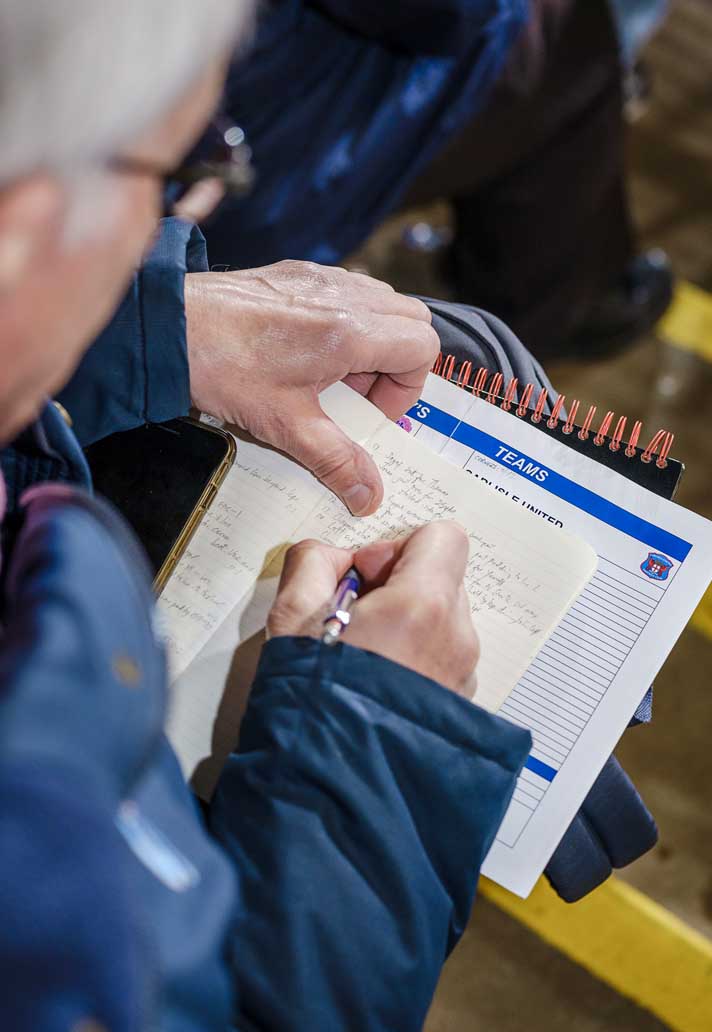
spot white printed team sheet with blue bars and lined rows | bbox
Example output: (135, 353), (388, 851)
(401, 376), (712, 896)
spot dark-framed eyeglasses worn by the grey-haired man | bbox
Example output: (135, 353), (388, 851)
(108, 117), (256, 216)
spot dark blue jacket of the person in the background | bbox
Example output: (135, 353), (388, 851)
(200, 0), (530, 267)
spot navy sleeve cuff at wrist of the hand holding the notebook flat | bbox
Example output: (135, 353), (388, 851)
(58, 219), (207, 446)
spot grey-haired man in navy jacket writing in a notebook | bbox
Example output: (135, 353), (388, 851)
(0, 0), (530, 1032)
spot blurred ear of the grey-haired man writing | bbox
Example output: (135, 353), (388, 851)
(0, 174), (67, 293)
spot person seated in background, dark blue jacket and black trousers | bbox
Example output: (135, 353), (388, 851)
(198, 0), (672, 359)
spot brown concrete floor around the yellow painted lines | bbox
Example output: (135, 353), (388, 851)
(351, 0), (712, 1032)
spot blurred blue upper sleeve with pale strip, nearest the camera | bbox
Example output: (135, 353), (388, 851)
(0, 484), (234, 1032)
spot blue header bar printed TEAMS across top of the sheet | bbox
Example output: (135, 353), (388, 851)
(409, 402), (692, 562)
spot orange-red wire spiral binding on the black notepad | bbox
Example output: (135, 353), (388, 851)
(431, 354), (675, 470)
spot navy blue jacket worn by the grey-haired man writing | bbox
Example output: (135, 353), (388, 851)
(0, 217), (530, 1032)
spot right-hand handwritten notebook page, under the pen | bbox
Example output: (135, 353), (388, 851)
(297, 423), (596, 712)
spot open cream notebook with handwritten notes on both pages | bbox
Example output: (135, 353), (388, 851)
(160, 384), (597, 797)
